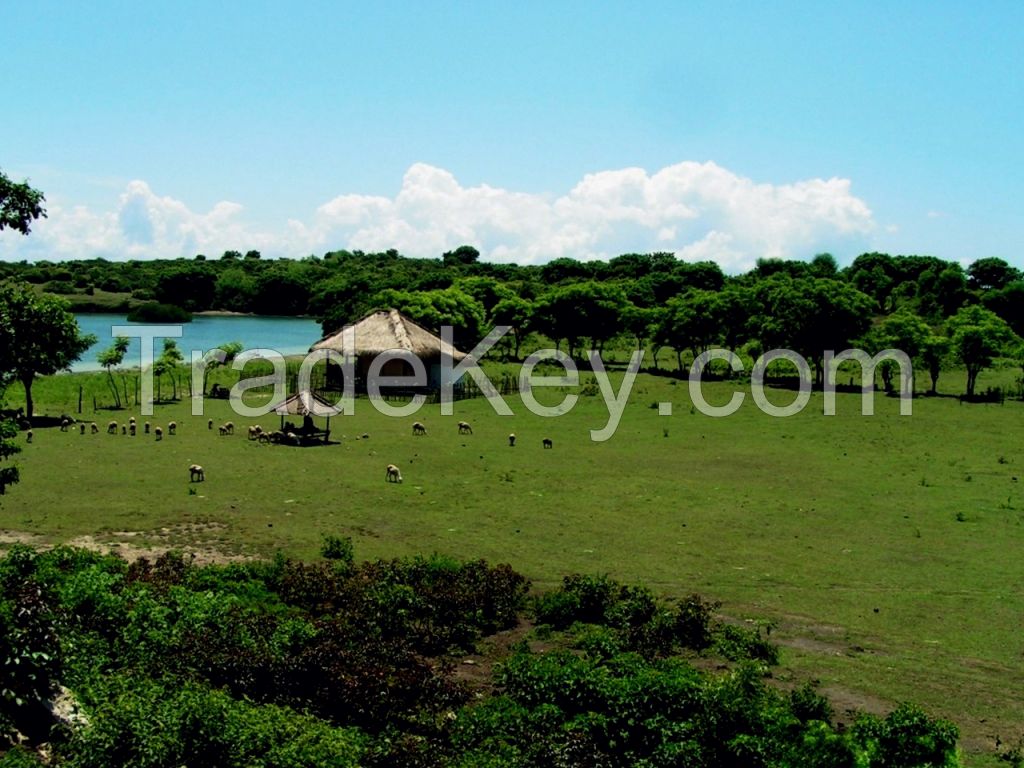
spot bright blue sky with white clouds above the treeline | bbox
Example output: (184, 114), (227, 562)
(0, 2), (1024, 271)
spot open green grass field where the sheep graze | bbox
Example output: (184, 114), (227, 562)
(0, 370), (1024, 765)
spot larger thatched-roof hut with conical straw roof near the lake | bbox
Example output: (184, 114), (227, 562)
(310, 309), (466, 390)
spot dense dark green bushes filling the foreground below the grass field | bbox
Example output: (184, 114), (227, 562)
(0, 538), (957, 768)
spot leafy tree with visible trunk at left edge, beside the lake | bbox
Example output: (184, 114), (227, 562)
(0, 283), (96, 419)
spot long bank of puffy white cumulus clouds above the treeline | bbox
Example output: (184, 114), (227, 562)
(0, 162), (876, 271)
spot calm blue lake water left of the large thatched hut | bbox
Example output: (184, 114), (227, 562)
(72, 314), (322, 371)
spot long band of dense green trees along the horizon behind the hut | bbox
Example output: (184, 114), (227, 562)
(0, 246), (1024, 393)
